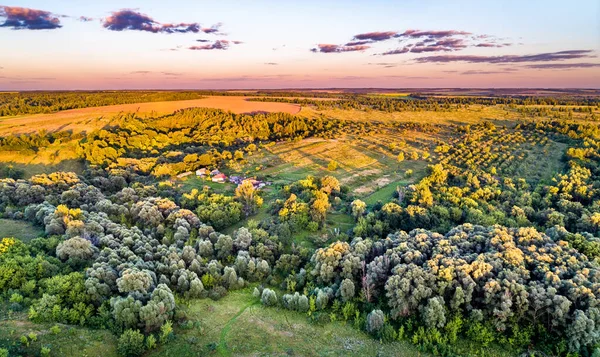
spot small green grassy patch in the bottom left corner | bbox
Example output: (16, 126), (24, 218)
(0, 316), (117, 357)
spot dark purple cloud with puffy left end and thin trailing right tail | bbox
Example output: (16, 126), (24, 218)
(103, 9), (209, 33)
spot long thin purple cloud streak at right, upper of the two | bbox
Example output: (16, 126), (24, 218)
(415, 50), (595, 63)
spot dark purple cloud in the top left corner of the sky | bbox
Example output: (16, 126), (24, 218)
(0, 6), (62, 30)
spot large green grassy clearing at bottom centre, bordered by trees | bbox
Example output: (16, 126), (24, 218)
(148, 288), (426, 357)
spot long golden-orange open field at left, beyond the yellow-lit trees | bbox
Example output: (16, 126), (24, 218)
(0, 96), (300, 136)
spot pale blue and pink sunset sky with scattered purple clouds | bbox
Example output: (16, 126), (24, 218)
(0, 0), (600, 91)
